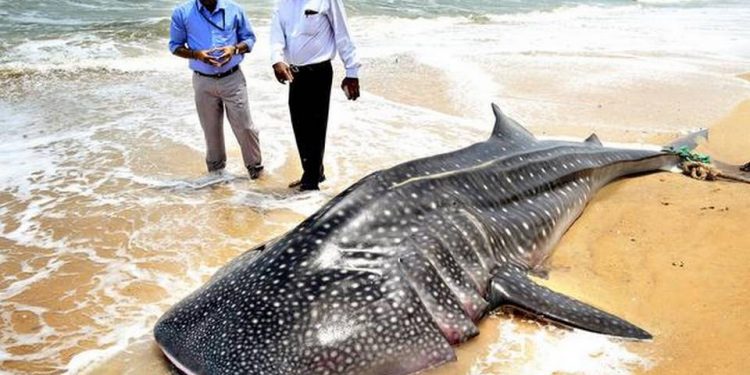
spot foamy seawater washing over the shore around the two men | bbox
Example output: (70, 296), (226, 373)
(0, 0), (750, 374)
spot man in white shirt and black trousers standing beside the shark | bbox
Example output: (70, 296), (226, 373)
(271, 0), (361, 191)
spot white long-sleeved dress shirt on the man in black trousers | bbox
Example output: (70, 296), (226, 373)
(271, 0), (361, 78)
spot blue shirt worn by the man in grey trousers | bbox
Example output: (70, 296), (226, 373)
(169, 0), (255, 75)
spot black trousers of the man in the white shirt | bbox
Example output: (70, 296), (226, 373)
(289, 61), (333, 188)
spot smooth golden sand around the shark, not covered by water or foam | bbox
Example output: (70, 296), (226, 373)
(75, 101), (750, 375)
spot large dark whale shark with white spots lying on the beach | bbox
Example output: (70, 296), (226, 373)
(154, 104), (680, 375)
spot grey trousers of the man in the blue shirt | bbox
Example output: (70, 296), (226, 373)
(193, 70), (261, 171)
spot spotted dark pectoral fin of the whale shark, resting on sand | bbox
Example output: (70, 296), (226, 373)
(489, 267), (651, 340)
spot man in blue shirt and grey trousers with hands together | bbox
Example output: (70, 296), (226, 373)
(169, 0), (263, 179)
